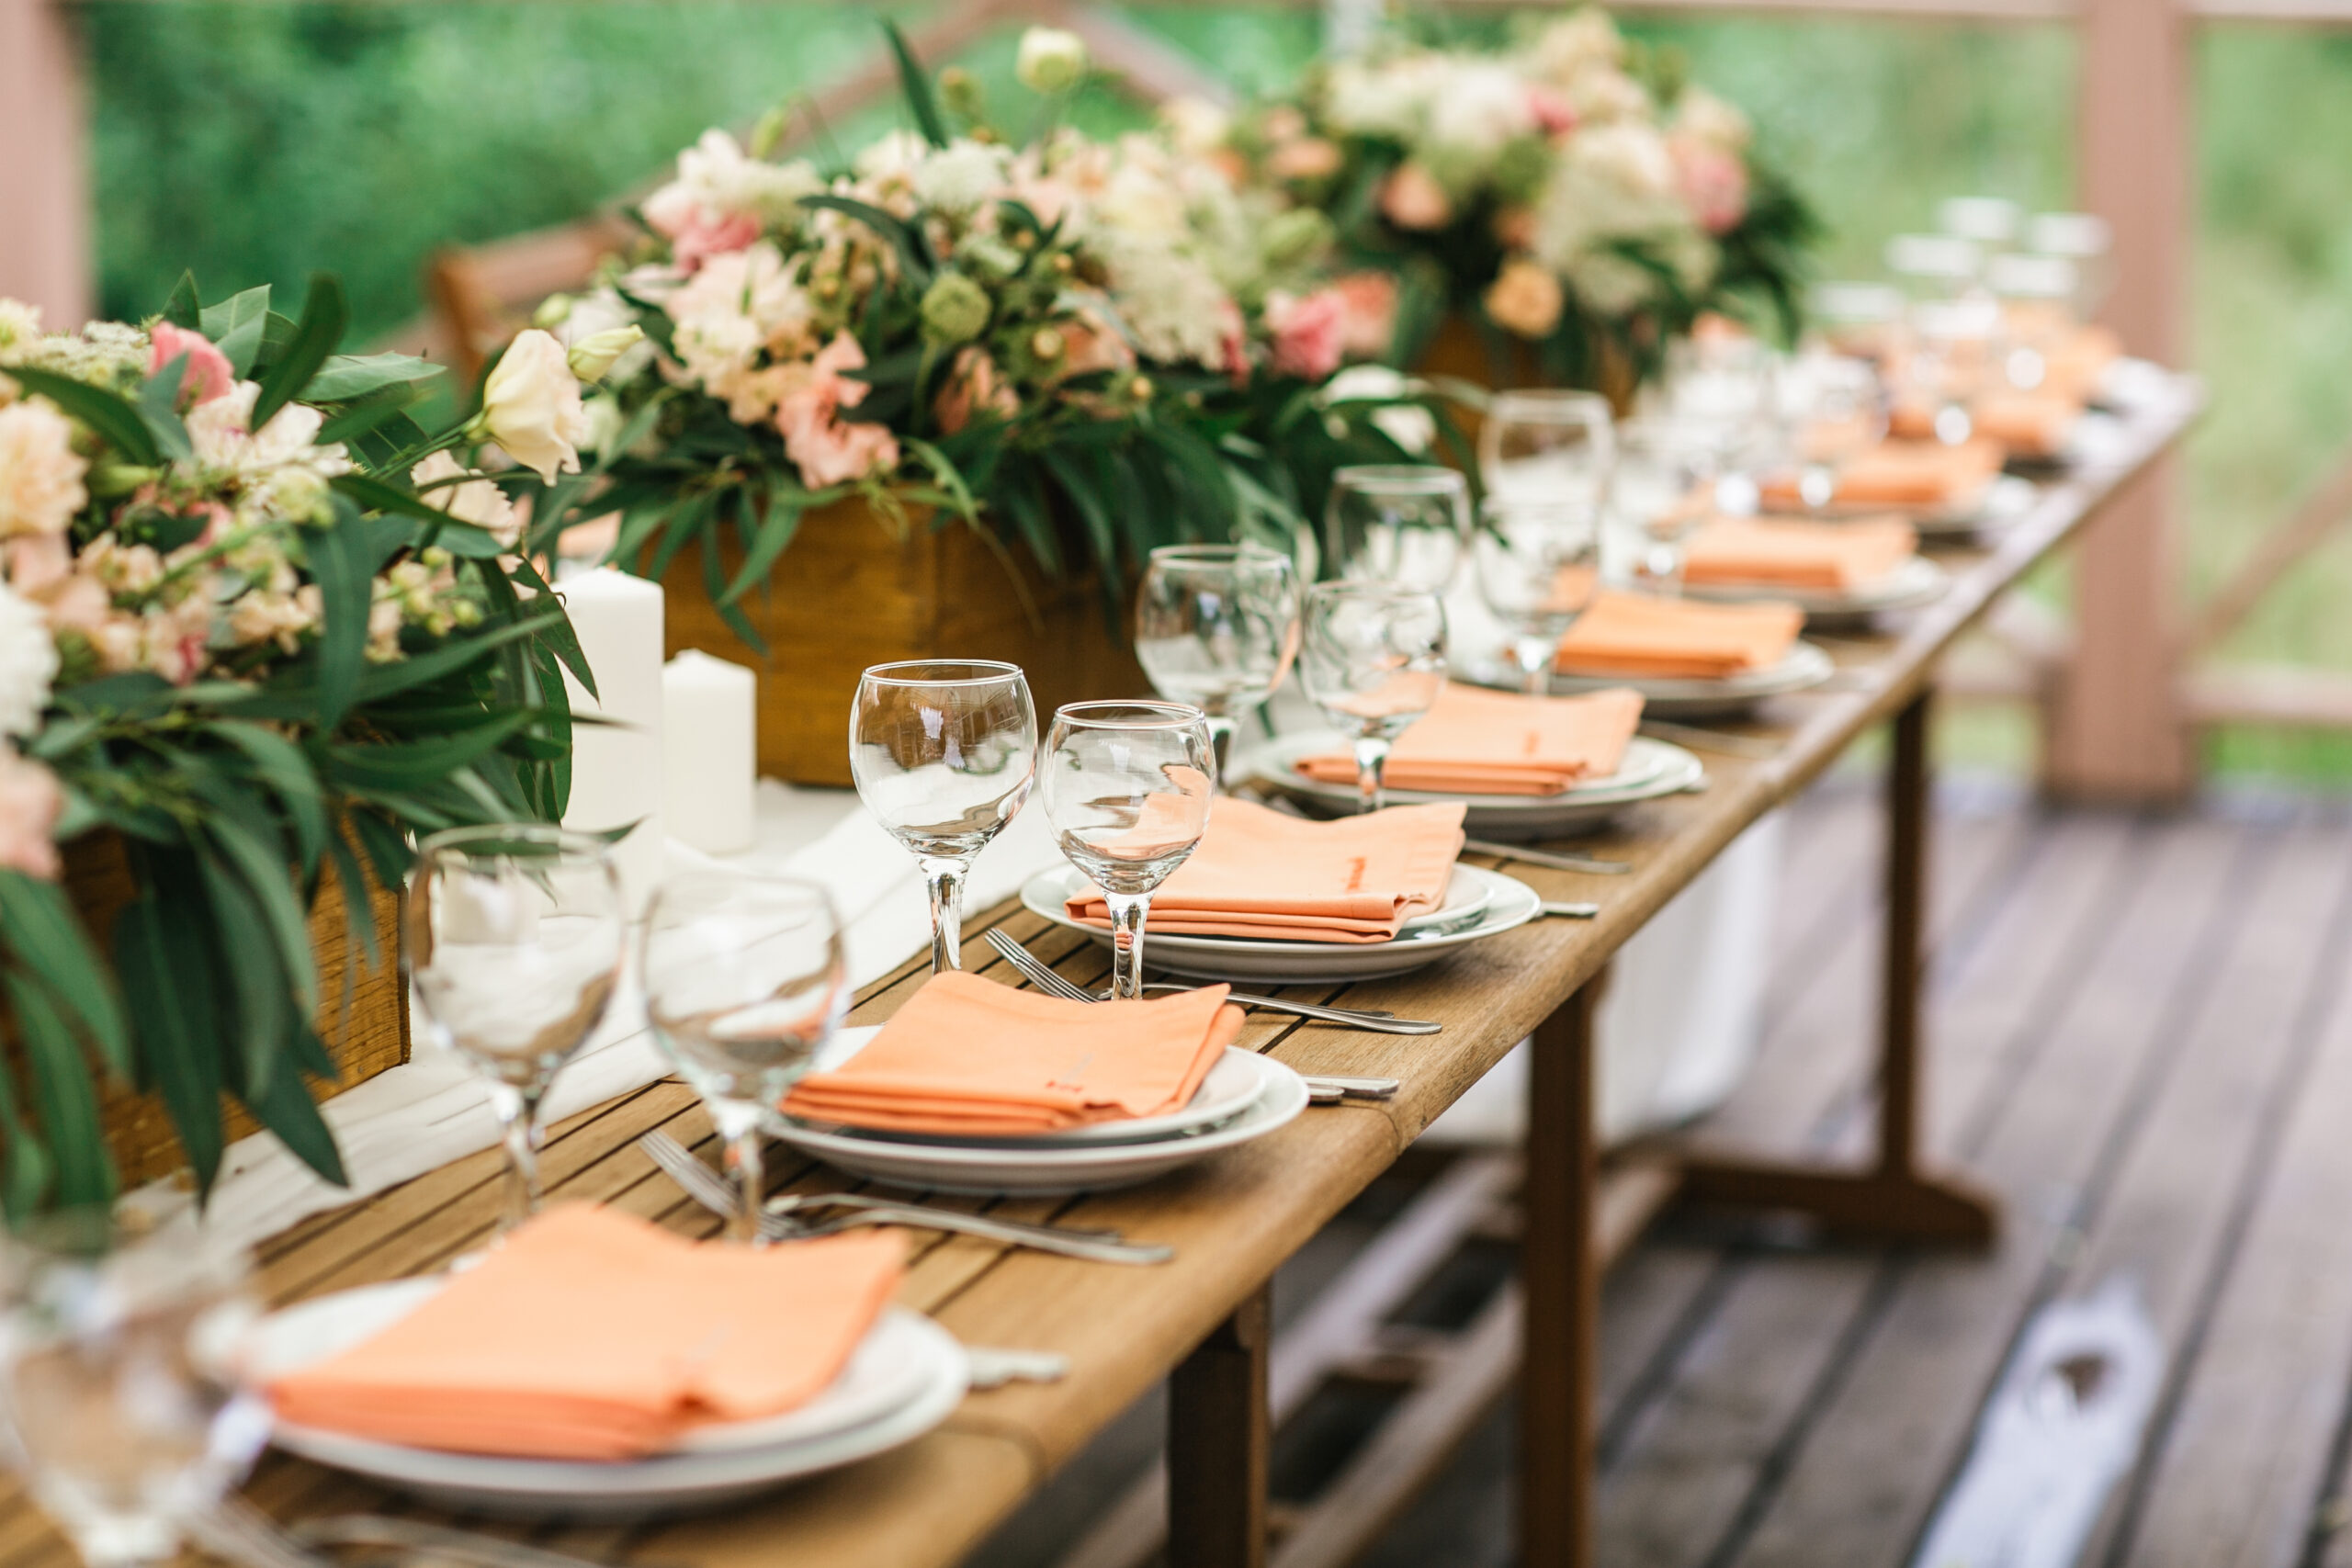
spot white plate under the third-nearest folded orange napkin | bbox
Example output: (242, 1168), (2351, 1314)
(1021, 865), (1543, 985)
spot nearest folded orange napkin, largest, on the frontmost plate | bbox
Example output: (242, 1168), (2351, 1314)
(268, 1203), (906, 1460)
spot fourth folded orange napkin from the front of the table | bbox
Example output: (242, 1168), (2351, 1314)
(1298, 684), (1642, 799)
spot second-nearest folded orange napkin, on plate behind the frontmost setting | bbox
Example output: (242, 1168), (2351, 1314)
(783, 971), (1242, 1138)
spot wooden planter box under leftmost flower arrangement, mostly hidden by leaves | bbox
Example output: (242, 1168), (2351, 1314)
(63, 832), (409, 1190)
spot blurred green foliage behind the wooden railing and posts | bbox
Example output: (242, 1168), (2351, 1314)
(85, 0), (2352, 781)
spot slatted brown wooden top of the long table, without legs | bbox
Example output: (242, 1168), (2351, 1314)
(0, 376), (2201, 1568)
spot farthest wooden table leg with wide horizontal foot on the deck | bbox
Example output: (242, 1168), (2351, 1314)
(1681, 689), (1999, 1246)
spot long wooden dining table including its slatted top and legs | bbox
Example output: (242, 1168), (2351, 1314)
(0, 378), (2201, 1568)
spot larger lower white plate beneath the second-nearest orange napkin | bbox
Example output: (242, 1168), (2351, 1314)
(769, 1058), (1307, 1194)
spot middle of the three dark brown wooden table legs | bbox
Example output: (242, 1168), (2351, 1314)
(1520, 976), (1601, 1568)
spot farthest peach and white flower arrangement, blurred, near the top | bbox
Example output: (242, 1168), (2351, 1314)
(1169, 9), (1815, 392)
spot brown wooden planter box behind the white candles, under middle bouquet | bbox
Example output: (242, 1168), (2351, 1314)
(661, 501), (1150, 785)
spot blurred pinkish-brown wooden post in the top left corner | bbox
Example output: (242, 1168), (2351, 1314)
(0, 0), (94, 332)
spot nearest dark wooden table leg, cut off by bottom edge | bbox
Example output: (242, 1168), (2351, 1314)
(1167, 1286), (1275, 1568)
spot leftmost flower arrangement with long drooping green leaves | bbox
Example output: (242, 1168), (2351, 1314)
(0, 277), (593, 1213)
